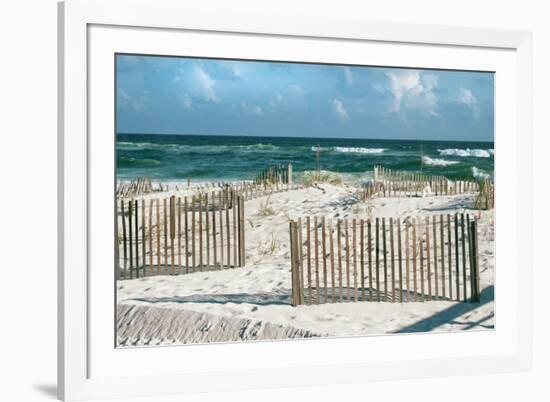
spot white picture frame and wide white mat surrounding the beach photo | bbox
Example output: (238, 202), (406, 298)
(58, 0), (532, 400)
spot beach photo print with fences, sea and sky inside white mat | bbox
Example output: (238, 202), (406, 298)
(115, 54), (495, 348)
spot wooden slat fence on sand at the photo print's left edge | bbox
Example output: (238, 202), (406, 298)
(115, 191), (246, 279)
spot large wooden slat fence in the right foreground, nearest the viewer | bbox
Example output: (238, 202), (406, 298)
(290, 213), (480, 306)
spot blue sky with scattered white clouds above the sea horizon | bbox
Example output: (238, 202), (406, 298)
(116, 55), (494, 141)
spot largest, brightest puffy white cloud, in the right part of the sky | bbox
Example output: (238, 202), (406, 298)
(386, 70), (438, 115)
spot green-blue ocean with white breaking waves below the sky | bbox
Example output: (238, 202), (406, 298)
(116, 134), (494, 181)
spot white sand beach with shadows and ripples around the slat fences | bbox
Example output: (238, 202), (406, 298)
(117, 183), (495, 346)
